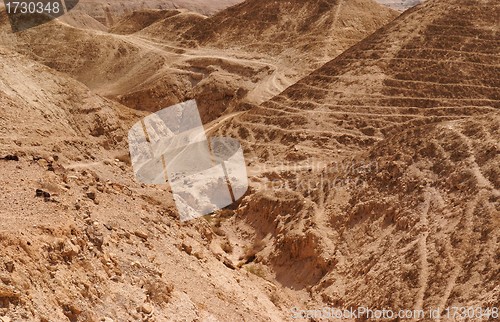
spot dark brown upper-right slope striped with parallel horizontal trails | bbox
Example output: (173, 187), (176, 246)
(220, 1), (500, 160)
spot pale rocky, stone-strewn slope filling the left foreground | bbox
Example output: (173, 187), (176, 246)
(0, 48), (291, 321)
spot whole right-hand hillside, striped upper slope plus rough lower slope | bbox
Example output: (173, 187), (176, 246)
(213, 0), (500, 310)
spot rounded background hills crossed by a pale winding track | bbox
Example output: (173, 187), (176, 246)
(0, 0), (397, 121)
